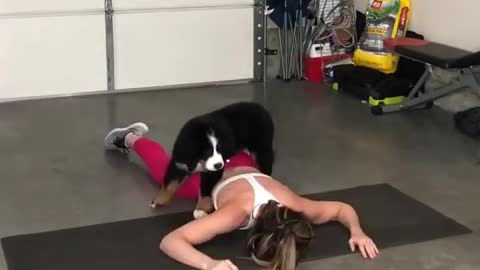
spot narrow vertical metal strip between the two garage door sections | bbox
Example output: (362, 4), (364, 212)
(105, 0), (115, 91)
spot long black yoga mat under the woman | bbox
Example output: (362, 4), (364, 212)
(2, 184), (471, 270)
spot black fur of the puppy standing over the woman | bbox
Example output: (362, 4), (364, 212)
(156, 102), (274, 210)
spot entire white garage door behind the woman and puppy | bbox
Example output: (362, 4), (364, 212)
(0, 0), (262, 99)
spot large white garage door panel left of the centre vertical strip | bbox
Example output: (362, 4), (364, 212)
(0, 15), (106, 98)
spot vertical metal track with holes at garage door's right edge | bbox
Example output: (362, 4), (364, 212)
(253, 0), (267, 82)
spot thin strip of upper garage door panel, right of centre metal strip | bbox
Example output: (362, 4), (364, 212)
(113, 0), (253, 9)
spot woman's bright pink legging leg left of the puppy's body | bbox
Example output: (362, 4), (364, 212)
(133, 137), (200, 199)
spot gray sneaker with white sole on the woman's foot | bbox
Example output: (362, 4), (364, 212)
(104, 122), (148, 153)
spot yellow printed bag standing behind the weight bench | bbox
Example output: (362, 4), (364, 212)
(353, 0), (412, 74)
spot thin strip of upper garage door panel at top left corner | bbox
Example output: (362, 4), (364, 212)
(0, 0), (104, 15)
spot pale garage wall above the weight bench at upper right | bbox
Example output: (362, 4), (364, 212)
(355, 0), (480, 51)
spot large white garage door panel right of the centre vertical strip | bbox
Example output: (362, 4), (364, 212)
(114, 8), (253, 89)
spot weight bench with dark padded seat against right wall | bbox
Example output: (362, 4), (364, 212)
(371, 38), (480, 115)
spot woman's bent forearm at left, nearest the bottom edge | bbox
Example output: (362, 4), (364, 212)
(160, 235), (212, 270)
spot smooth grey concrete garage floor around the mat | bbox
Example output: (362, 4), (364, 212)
(0, 82), (480, 270)
